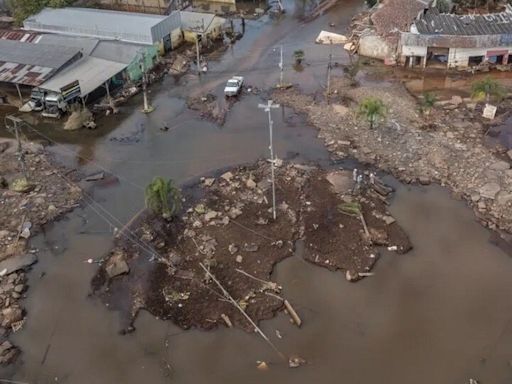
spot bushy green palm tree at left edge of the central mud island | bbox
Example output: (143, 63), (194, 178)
(144, 176), (181, 220)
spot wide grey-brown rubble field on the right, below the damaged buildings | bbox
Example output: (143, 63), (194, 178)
(274, 79), (512, 232)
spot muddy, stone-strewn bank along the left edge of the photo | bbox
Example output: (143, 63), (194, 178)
(0, 139), (82, 364)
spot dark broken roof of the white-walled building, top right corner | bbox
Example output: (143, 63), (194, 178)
(415, 6), (512, 36)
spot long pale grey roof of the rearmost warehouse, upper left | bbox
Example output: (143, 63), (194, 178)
(23, 7), (184, 45)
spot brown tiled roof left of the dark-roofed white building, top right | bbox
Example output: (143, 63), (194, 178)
(371, 0), (432, 42)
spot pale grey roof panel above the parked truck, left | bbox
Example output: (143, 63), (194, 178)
(39, 56), (126, 97)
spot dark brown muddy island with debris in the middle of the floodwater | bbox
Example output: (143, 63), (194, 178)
(93, 162), (410, 331)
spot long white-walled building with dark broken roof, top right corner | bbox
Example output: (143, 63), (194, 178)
(399, 5), (512, 69)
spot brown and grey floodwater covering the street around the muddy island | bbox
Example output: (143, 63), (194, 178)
(0, 0), (512, 384)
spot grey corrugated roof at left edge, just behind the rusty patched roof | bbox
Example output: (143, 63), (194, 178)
(0, 40), (80, 69)
